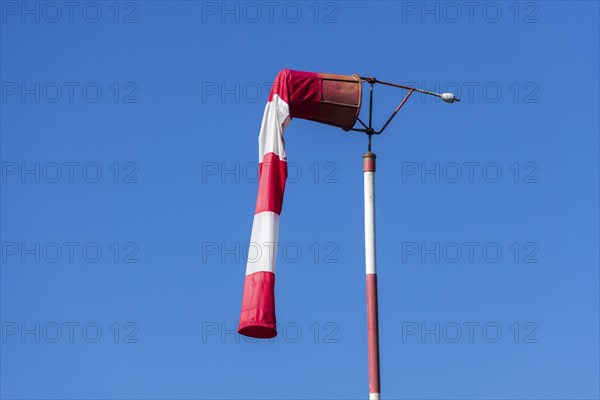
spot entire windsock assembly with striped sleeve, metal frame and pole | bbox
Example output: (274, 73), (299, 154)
(238, 69), (460, 400)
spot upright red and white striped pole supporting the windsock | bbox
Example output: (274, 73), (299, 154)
(363, 151), (381, 400)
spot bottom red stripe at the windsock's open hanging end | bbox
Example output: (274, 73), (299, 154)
(238, 272), (277, 339)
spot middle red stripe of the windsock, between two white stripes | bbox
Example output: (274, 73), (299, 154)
(254, 153), (287, 214)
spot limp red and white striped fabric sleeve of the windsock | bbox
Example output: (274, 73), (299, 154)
(238, 69), (322, 338)
